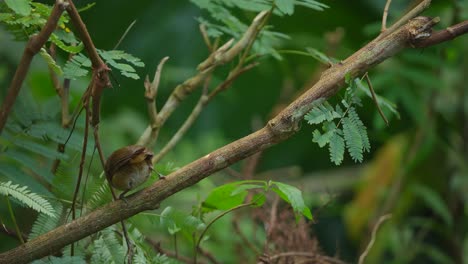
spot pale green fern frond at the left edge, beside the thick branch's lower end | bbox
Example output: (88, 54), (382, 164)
(0, 181), (56, 217)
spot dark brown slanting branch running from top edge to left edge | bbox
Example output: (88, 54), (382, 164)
(0, 0), (67, 134)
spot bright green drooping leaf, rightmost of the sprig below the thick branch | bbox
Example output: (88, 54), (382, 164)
(272, 182), (313, 221)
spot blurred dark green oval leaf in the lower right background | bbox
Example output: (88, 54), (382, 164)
(411, 184), (453, 227)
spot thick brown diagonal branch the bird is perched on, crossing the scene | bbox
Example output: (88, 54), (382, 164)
(0, 12), (464, 263)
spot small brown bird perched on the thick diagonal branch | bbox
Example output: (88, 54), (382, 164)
(104, 145), (154, 199)
